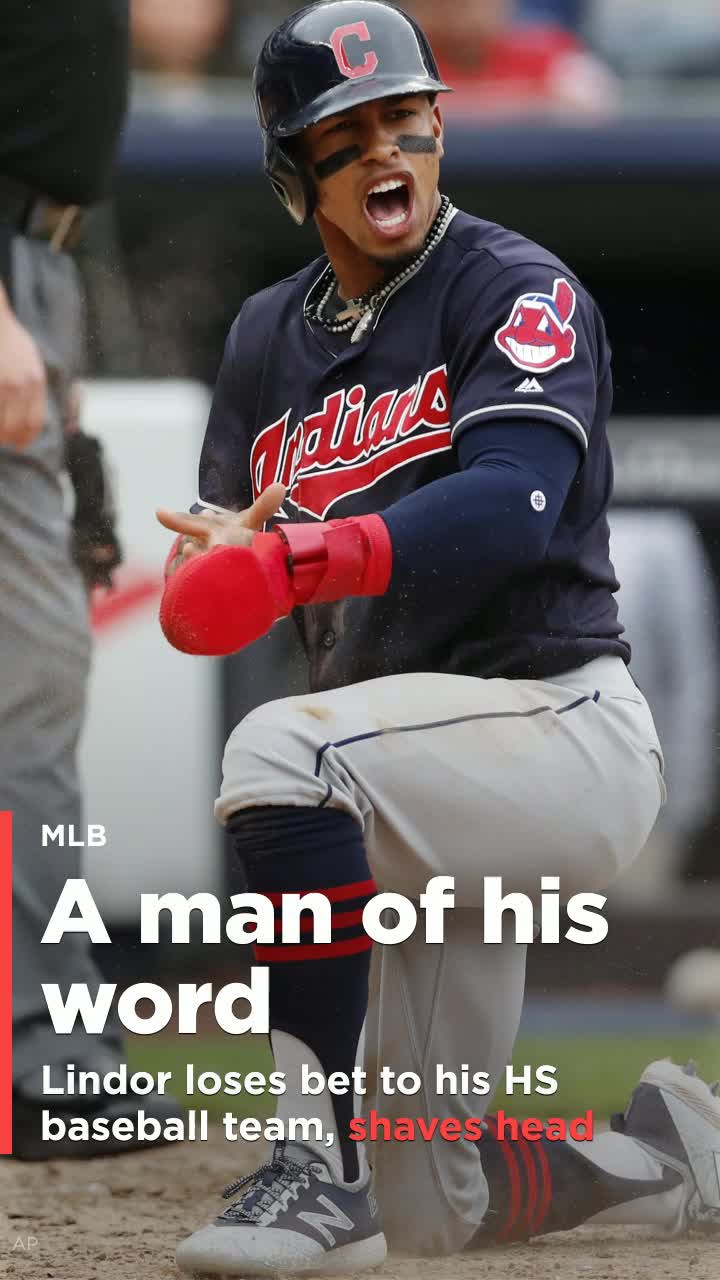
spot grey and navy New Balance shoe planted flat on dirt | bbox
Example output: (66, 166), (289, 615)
(176, 1143), (387, 1276)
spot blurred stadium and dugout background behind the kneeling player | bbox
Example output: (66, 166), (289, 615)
(81, 0), (720, 1114)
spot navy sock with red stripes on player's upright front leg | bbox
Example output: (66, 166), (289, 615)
(228, 805), (375, 1183)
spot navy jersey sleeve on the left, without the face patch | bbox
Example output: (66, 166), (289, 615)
(191, 303), (256, 513)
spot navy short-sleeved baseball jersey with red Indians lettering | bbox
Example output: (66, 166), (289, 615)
(193, 212), (629, 690)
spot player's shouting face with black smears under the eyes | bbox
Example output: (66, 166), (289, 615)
(298, 95), (443, 262)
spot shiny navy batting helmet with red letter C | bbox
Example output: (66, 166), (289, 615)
(252, 0), (450, 225)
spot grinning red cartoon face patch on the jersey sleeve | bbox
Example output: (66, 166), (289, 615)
(495, 279), (577, 374)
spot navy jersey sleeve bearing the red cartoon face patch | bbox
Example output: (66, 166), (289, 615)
(448, 264), (609, 453)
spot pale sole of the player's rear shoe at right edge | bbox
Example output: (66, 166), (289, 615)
(641, 1061), (720, 1212)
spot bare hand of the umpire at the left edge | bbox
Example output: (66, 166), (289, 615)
(0, 293), (46, 449)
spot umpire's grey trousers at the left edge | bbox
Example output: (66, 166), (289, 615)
(0, 237), (119, 1092)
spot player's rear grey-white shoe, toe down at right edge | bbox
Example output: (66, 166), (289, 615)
(611, 1059), (720, 1233)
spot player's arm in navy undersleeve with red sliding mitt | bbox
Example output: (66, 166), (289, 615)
(160, 426), (579, 655)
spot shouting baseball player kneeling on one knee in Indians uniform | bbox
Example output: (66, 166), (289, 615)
(159, 0), (720, 1276)
